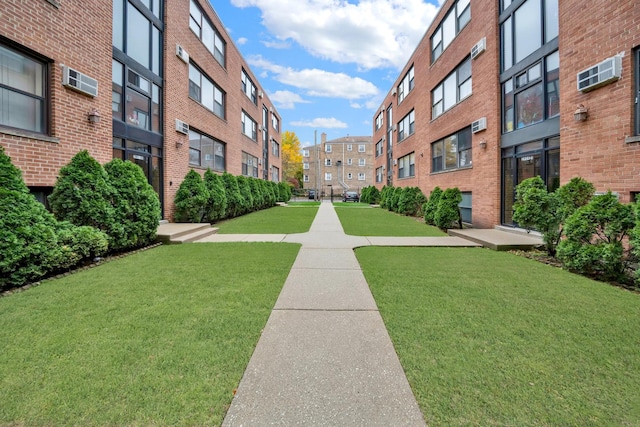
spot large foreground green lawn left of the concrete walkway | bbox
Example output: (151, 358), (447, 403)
(0, 243), (299, 426)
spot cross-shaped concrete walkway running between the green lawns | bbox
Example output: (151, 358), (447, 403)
(219, 203), (480, 426)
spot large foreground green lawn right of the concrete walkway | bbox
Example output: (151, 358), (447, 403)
(356, 247), (640, 426)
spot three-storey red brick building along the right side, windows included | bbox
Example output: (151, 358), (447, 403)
(373, 0), (640, 227)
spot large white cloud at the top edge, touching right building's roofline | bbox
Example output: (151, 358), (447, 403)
(231, 0), (439, 70)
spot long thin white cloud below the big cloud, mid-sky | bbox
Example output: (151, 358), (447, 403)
(247, 55), (379, 100)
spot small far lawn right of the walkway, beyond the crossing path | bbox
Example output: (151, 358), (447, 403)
(336, 203), (446, 236)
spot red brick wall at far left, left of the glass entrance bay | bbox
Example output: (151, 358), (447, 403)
(0, 0), (112, 186)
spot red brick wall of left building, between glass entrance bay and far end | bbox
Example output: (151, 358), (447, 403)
(164, 0), (282, 218)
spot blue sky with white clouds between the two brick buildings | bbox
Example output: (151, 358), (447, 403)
(212, 0), (442, 146)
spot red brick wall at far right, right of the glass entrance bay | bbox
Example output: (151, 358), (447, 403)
(559, 0), (640, 202)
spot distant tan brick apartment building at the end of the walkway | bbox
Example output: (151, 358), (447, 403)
(302, 133), (374, 196)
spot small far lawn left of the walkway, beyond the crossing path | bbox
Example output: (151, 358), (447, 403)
(215, 204), (318, 234)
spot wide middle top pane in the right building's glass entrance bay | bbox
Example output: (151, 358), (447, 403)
(514, 0), (542, 63)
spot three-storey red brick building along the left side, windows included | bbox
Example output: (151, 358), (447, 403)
(0, 0), (281, 219)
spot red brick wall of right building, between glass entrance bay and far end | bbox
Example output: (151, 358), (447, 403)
(373, 0), (500, 227)
